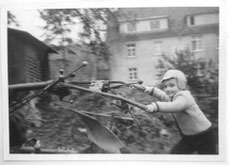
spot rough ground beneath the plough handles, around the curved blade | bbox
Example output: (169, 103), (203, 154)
(26, 90), (180, 154)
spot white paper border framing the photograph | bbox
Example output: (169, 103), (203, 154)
(0, 0), (228, 164)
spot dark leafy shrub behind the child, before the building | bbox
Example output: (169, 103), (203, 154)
(157, 49), (218, 96)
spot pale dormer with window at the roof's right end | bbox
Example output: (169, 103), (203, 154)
(187, 13), (219, 26)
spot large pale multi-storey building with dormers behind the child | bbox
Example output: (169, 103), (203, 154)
(107, 7), (219, 84)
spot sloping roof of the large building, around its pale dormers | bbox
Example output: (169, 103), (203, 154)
(108, 7), (219, 41)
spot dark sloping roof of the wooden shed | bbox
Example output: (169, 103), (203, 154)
(8, 28), (58, 54)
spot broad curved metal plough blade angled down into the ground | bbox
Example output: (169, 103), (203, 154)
(66, 108), (125, 153)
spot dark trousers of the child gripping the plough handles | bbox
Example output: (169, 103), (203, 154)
(170, 127), (217, 154)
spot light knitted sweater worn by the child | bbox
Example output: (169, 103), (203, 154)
(152, 88), (211, 135)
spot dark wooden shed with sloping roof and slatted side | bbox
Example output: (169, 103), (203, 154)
(8, 28), (57, 84)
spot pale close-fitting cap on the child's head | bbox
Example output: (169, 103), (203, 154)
(161, 69), (187, 90)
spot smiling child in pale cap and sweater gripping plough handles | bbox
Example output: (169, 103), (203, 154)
(145, 70), (217, 154)
